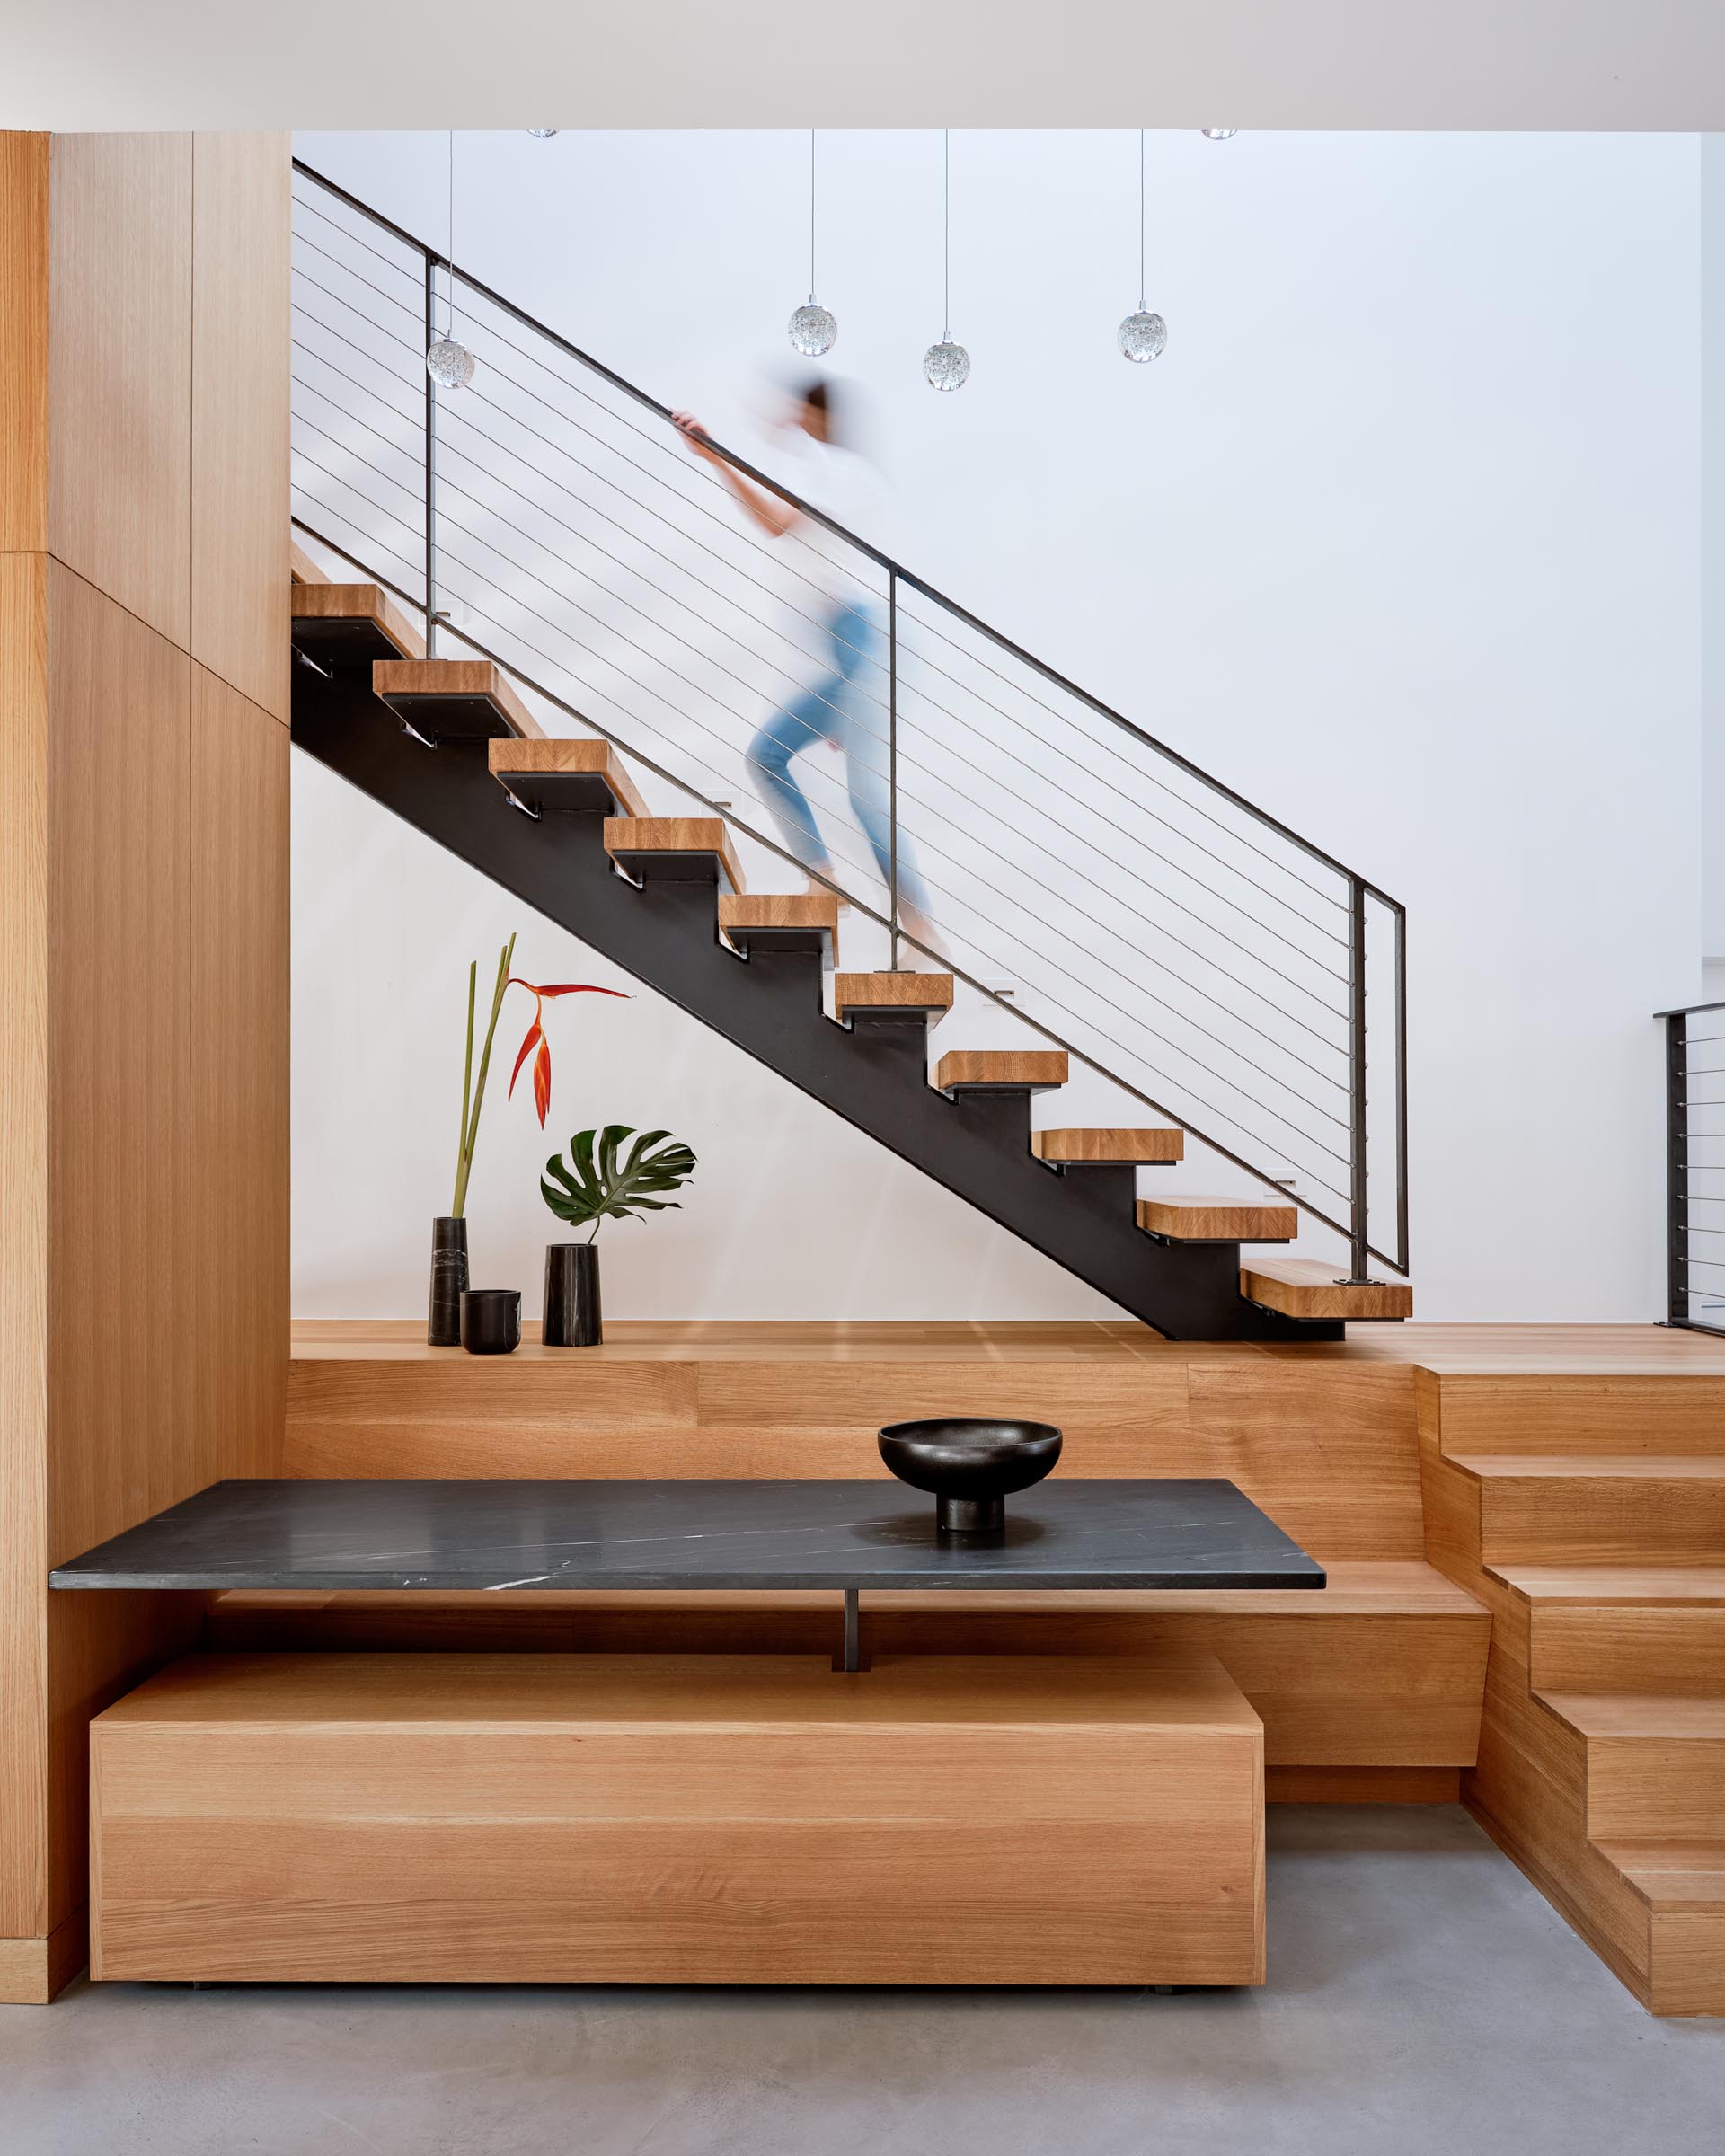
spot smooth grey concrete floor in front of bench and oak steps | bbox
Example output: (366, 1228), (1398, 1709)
(0, 1807), (1725, 2156)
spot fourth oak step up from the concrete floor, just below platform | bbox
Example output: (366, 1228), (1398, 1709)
(1449, 1454), (1725, 1565)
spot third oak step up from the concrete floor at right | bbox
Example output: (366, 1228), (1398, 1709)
(1492, 1565), (1725, 1692)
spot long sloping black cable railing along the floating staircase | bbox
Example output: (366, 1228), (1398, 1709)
(293, 162), (1408, 1278)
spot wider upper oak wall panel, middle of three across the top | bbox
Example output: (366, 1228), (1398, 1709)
(48, 134), (192, 649)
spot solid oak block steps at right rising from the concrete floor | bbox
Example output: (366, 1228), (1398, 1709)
(1417, 1371), (1725, 2014)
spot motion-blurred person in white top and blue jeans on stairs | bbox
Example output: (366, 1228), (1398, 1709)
(670, 376), (944, 955)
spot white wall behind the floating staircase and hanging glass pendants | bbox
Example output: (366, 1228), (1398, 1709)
(296, 134), (1702, 1320)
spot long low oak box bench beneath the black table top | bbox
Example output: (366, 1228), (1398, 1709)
(91, 1651), (1263, 1985)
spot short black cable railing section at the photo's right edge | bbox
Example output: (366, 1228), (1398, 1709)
(1659, 1003), (1725, 1332)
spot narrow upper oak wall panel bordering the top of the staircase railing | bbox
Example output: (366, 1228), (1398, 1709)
(190, 134), (291, 724)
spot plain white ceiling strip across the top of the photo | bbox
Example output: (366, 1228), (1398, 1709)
(0, 0), (1725, 131)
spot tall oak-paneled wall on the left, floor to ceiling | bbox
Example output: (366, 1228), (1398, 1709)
(0, 136), (289, 1999)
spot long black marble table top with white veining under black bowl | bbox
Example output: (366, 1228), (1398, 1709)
(49, 1475), (1324, 1594)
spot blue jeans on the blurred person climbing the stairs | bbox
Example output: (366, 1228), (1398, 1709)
(748, 599), (929, 916)
